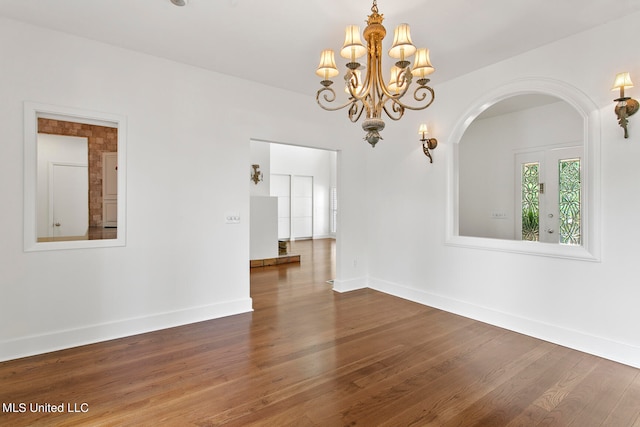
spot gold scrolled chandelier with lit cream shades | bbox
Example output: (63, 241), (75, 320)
(316, 0), (435, 147)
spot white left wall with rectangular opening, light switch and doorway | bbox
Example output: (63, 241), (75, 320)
(0, 19), (365, 360)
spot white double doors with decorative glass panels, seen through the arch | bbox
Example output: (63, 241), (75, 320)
(515, 147), (582, 245)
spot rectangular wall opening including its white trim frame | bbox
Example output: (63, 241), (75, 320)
(24, 102), (126, 251)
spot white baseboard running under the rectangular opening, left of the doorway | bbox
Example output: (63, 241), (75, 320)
(0, 298), (253, 362)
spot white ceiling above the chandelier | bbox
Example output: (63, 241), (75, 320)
(0, 0), (640, 95)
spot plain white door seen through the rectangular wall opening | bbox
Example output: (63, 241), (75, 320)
(49, 163), (89, 238)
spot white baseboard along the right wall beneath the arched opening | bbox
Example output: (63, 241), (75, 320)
(368, 278), (640, 368)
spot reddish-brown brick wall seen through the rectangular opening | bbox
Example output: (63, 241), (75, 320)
(38, 118), (118, 227)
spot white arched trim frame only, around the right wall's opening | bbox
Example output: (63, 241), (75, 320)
(445, 78), (600, 261)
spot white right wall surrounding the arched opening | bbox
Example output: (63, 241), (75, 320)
(367, 10), (640, 367)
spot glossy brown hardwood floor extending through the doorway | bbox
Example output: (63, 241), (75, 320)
(0, 240), (640, 427)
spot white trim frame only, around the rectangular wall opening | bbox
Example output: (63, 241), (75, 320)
(24, 101), (127, 252)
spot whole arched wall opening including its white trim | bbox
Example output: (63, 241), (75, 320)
(447, 80), (600, 261)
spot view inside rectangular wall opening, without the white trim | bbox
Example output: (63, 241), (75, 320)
(37, 117), (118, 242)
